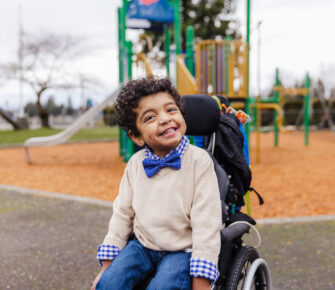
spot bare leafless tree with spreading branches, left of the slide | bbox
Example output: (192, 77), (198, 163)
(0, 32), (87, 127)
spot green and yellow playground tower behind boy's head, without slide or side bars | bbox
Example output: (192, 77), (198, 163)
(118, 0), (258, 161)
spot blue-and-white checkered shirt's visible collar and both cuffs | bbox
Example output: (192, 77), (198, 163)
(97, 136), (219, 281)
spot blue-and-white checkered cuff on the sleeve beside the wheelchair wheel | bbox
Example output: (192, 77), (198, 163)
(190, 258), (219, 282)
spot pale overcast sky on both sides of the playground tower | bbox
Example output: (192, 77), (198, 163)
(0, 0), (335, 108)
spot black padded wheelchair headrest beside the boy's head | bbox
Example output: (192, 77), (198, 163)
(182, 95), (220, 136)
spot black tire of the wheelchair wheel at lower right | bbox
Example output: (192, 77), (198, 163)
(224, 247), (267, 290)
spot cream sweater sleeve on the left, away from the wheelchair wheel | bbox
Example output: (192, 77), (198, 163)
(103, 160), (135, 251)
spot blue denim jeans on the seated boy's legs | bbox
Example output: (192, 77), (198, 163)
(95, 240), (191, 290)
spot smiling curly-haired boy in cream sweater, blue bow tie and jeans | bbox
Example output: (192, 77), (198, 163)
(92, 76), (222, 290)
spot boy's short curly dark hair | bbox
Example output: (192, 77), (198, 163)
(115, 76), (184, 137)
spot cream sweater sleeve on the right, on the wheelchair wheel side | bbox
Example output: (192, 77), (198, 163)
(190, 156), (222, 280)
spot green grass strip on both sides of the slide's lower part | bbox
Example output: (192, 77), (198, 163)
(0, 127), (119, 145)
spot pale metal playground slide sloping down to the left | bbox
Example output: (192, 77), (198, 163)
(24, 87), (121, 163)
